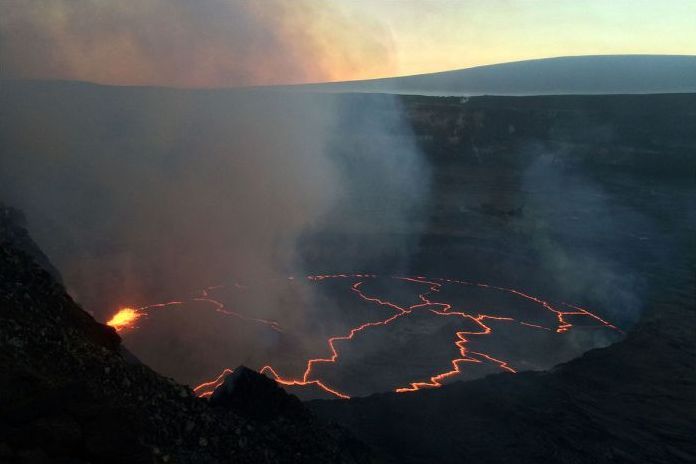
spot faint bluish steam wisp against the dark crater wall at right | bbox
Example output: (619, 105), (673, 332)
(520, 152), (655, 327)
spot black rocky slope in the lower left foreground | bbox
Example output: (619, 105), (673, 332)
(0, 208), (366, 463)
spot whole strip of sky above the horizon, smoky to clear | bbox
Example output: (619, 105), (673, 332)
(0, 0), (696, 87)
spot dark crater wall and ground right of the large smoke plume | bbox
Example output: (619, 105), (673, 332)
(311, 95), (696, 463)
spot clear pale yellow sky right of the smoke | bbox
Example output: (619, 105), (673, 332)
(358, 0), (696, 74)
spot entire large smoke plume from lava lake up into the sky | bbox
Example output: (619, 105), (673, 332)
(0, 0), (429, 381)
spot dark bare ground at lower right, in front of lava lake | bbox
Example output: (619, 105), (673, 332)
(311, 267), (696, 464)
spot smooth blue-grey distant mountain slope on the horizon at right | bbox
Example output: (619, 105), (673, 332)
(295, 55), (696, 95)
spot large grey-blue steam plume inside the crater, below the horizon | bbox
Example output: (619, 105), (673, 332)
(0, 82), (429, 379)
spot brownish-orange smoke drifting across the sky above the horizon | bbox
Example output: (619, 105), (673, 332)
(0, 0), (395, 87)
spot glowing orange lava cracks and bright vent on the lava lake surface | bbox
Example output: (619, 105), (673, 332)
(108, 274), (621, 399)
